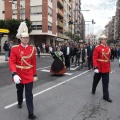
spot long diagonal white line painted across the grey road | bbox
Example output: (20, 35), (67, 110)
(4, 70), (89, 109)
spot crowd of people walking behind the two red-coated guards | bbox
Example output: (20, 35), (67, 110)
(36, 41), (120, 74)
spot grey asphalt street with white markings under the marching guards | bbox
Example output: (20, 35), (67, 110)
(0, 56), (120, 120)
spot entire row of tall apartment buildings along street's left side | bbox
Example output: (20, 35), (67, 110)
(0, 0), (85, 46)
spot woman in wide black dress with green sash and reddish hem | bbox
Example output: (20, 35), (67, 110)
(50, 47), (66, 75)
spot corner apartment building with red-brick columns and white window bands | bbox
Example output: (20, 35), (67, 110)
(4, 0), (57, 45)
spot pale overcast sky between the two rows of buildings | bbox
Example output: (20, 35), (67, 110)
(81, 0), (117, 33)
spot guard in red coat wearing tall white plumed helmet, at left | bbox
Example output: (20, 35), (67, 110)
(9, 22), (37, 120)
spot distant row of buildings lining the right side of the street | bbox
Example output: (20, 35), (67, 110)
(104, 0), (120, 44)
